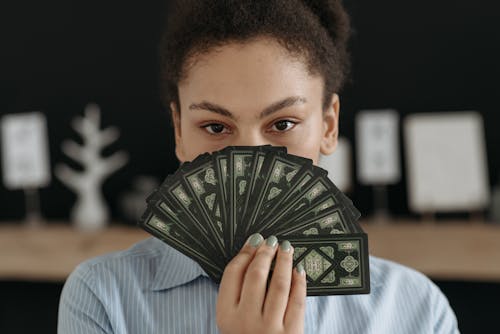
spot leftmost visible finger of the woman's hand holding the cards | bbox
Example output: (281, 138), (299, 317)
(218, 233), (264, 307)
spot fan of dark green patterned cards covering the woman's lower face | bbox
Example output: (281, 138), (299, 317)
(140, 145), (370, 296)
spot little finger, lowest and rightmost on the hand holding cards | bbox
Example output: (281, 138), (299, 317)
(284, 263), (306, 330)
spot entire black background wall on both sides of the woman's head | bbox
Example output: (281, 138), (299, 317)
(0, 0), (500, 220)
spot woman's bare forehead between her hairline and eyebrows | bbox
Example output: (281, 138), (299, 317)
(179, 40), (323, 111)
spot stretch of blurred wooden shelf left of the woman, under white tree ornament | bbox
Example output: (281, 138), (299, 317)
(0, 223), (149, 281)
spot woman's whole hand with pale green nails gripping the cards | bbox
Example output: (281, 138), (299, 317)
(217, 234), (306, 334)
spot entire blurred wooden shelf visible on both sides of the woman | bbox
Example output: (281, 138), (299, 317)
(0, 221), (500, 282)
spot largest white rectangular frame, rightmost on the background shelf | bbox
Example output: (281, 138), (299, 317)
(404, 111), (490, 213)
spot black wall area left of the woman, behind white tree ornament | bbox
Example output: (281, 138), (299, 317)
(0, 0), (177, 220)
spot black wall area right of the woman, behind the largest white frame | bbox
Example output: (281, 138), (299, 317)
(341, 0), (500, 215)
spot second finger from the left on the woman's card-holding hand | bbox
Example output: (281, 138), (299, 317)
(239, 236), (278, 315)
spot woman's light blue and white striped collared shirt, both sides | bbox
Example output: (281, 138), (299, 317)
(58, 238), (458, 334)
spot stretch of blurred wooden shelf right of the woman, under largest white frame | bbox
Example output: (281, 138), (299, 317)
(363, 221), (500, 282)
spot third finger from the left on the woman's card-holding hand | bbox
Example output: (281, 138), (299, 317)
(263, 240), (293, 324)
